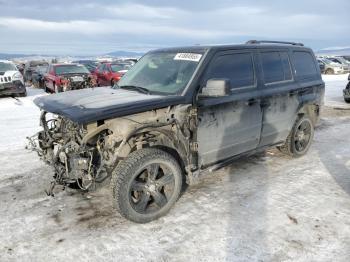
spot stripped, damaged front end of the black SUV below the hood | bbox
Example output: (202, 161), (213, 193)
(29, 106), (197, 195)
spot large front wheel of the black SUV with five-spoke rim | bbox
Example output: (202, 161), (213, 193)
(111, 148), (182, 223)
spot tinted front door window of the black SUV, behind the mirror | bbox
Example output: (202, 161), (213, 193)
(207, 53), (254, 88)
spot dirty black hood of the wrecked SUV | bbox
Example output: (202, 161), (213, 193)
(34, 87), (184, 124)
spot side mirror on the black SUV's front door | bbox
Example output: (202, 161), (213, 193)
(200, 78), (231, 97)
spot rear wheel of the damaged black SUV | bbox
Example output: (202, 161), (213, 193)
(278, 116), (314, 157)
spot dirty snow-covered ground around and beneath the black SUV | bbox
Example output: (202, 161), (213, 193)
(0, 75), (350, 261)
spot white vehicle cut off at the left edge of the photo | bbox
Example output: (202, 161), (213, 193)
(0, 60), (27, 96)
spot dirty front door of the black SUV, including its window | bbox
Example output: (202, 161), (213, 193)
(197, 50), (262, 167)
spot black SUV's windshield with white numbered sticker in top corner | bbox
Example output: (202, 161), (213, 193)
(118, 52), (202, 94)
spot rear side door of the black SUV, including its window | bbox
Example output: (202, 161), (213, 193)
(259, 49), (299, 147)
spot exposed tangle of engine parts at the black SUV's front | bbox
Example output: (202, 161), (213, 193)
(30, 112), (105, 195)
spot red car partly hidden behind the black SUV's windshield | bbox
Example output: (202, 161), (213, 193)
(94, 62), (130, 86)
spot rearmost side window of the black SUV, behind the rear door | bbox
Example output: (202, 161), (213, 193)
(293, 51), (318, 78)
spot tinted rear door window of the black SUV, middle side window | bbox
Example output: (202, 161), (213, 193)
(261, 51), (292, 84)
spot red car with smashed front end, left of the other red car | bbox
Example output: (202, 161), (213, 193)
(44, 64), (96, 93)
